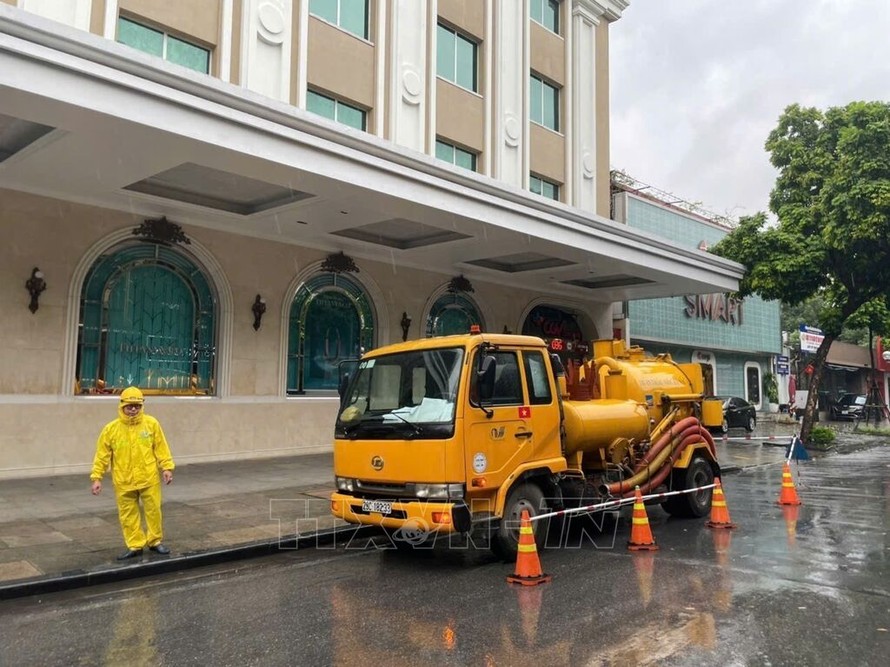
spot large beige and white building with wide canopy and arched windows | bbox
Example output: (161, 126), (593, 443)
(0, 0), (742, 477)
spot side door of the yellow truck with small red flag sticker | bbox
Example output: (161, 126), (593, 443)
(465, 350), (534, 488)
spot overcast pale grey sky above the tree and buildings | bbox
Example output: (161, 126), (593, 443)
(610, 0), (890, 223)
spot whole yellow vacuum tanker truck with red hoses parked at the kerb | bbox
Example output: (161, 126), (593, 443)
(331, 332), (723, 558)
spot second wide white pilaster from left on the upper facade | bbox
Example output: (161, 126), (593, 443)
(386, 0), (436, 152)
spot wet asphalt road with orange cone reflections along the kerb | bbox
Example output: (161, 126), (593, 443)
(0, 447), (890, 666)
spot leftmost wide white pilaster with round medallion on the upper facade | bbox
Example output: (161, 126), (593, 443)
(241, 0), (293, 102)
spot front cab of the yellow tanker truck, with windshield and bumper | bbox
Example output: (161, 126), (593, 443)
(331, 334), (566, 538)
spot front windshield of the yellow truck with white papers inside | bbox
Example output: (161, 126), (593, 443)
(336, 348), (464, 438)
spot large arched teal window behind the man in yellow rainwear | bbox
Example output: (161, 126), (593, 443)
(75, 243), (219, 395)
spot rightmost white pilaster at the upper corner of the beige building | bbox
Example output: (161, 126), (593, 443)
(569, 0), (601, 212)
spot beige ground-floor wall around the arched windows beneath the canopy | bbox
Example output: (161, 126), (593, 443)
(0, 190), (584, 479)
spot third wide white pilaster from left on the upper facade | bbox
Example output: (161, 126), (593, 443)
(490, 0), (529, 188)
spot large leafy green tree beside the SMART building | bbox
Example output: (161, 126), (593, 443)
(712, 102), (890, 442)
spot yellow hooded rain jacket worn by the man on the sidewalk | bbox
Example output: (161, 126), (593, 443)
(90, 401), (175, 492)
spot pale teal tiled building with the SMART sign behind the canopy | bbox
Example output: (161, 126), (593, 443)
(613, 175), (787, 411)
